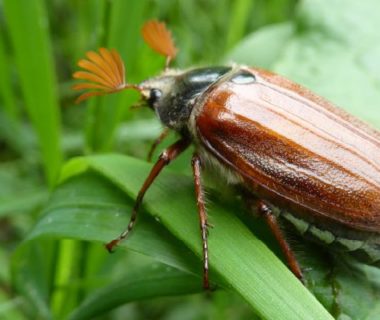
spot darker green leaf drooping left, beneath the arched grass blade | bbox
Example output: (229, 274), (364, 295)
(28, 171), (198, 272)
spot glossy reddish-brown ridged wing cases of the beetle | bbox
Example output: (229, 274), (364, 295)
(194, 69), (380, 233)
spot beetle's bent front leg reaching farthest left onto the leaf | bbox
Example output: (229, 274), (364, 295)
(106, 139), (190, 252)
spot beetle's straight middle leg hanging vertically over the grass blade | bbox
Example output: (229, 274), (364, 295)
(191, 153), (210, 289)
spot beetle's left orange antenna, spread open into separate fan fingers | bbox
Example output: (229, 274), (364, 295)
(73, 48), (142, 103)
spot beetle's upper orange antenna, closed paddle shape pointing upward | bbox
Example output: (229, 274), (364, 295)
(141, 20), (178, 70)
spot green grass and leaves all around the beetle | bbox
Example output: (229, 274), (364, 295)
(0, 0), (380, 320)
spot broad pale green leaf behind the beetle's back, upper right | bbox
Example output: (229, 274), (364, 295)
(227, 0), (380, 127)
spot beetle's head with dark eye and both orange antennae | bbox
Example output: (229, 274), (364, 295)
(73, 20), (194, 131)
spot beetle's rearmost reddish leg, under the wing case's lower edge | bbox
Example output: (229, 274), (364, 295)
(257, 200), (303, 282)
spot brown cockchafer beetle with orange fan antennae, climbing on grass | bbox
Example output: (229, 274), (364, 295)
(74, 21), (380, 288)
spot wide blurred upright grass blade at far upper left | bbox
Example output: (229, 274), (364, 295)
(4, 0), (62, 185)
